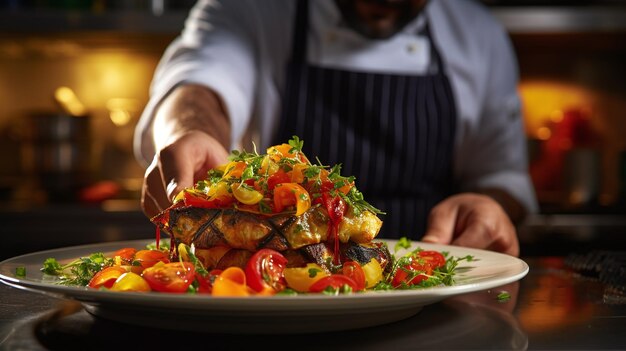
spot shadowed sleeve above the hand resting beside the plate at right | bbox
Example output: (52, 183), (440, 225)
(457, 18), (538, 213)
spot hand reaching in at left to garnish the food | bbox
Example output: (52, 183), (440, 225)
(141, 131), (228, 218)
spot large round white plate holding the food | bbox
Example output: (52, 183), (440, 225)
(0, 240), (528, 334)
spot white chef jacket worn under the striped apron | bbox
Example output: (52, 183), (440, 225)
(135, 0), (537, 212)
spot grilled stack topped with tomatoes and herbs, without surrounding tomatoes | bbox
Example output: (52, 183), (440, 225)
(152, 137), (389, 271)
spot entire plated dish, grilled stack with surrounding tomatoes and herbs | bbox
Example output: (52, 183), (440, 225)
(36, 136), (472, 296)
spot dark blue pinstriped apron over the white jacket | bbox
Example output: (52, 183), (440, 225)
(274, 0), (456, 239)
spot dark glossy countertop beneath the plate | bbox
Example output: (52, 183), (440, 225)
(0, 257), (626, 350)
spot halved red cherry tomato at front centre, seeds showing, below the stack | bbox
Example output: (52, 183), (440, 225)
(245, 249), (287, 294)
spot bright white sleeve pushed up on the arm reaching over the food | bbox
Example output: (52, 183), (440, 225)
(134, 0), (256, 163)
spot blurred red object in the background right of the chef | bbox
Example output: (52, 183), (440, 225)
(530, 108), (596, 195)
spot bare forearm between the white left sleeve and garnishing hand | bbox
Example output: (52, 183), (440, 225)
(153, 84), (230, 150)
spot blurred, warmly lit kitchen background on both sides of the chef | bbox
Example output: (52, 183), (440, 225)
(0, 0), (626, 259)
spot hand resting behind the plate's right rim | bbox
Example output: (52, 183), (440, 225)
(422, 193), (519, 256)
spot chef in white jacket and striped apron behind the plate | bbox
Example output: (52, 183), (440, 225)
(135, 0), (537, 255)
